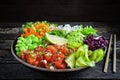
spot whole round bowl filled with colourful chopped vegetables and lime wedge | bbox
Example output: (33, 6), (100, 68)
(11, 21), (108, 72)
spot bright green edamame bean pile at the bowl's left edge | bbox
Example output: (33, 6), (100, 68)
(15, 34), (42, 54)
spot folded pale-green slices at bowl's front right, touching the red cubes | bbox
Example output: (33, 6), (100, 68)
(65, 45), (95, 68)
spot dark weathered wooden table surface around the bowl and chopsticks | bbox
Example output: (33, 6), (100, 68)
(0, 22), (120, 80)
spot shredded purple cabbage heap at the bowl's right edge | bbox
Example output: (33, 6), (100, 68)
(84, 35), (108, 50)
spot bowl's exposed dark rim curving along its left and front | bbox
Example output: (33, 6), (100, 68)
(11, 36), (87, 72)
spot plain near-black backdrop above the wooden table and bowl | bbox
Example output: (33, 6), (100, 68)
(0, 0), (120, 22)
